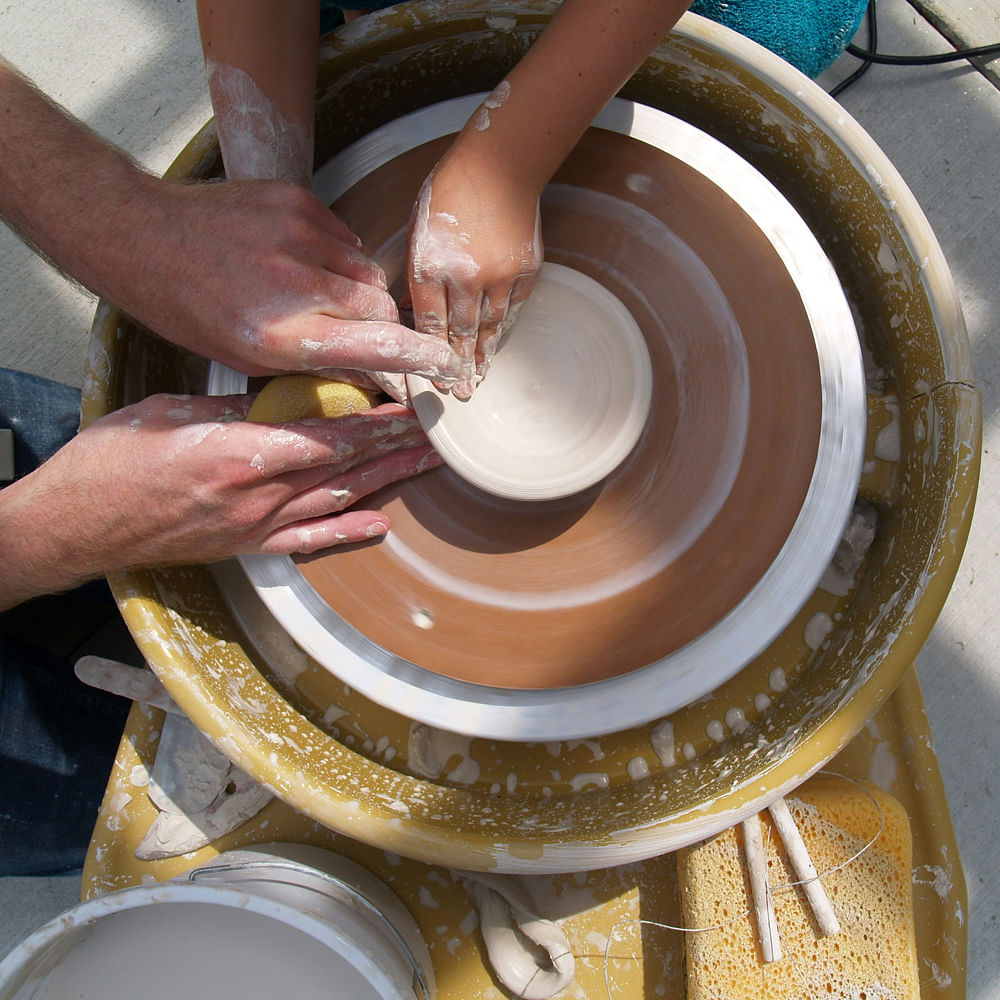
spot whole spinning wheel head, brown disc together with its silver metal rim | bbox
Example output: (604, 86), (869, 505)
(207, 97), (865, 740)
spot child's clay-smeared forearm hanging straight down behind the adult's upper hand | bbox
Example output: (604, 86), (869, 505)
(198, 0), (319, 188)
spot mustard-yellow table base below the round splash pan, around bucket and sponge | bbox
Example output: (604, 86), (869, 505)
(88, 668), (968, 1000)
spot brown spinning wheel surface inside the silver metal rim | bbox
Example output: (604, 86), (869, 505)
(298, 129), (821, 688)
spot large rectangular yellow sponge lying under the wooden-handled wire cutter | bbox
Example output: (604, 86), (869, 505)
(678, 776), (920, 1000)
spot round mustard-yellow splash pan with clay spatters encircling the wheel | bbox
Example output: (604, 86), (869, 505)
(84, 2), (981, 873)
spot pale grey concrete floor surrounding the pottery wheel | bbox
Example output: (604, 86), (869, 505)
(0, 0), (1000, 1000)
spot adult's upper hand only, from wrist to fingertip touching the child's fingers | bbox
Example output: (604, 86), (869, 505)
(127, 181), (460, 381)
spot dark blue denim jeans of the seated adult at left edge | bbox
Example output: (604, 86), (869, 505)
(0, 368), (128, 876)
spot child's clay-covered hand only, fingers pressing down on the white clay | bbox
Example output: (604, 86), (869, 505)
(409, 151), (542, 399)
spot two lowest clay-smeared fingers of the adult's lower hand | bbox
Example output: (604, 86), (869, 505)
(260, 446), (441, 555)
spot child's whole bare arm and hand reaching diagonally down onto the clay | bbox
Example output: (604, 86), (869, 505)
(409, 0), (689, 397)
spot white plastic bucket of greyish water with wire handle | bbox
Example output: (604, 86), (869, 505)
(0, 844), (434, 1000)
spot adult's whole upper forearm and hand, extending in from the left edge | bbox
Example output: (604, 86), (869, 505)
(0, 59), (460, 394)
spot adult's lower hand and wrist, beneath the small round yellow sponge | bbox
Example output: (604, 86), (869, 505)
(0, 395), (440, 608)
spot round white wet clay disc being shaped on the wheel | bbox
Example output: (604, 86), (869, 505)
(407, 263), (653, 500)
